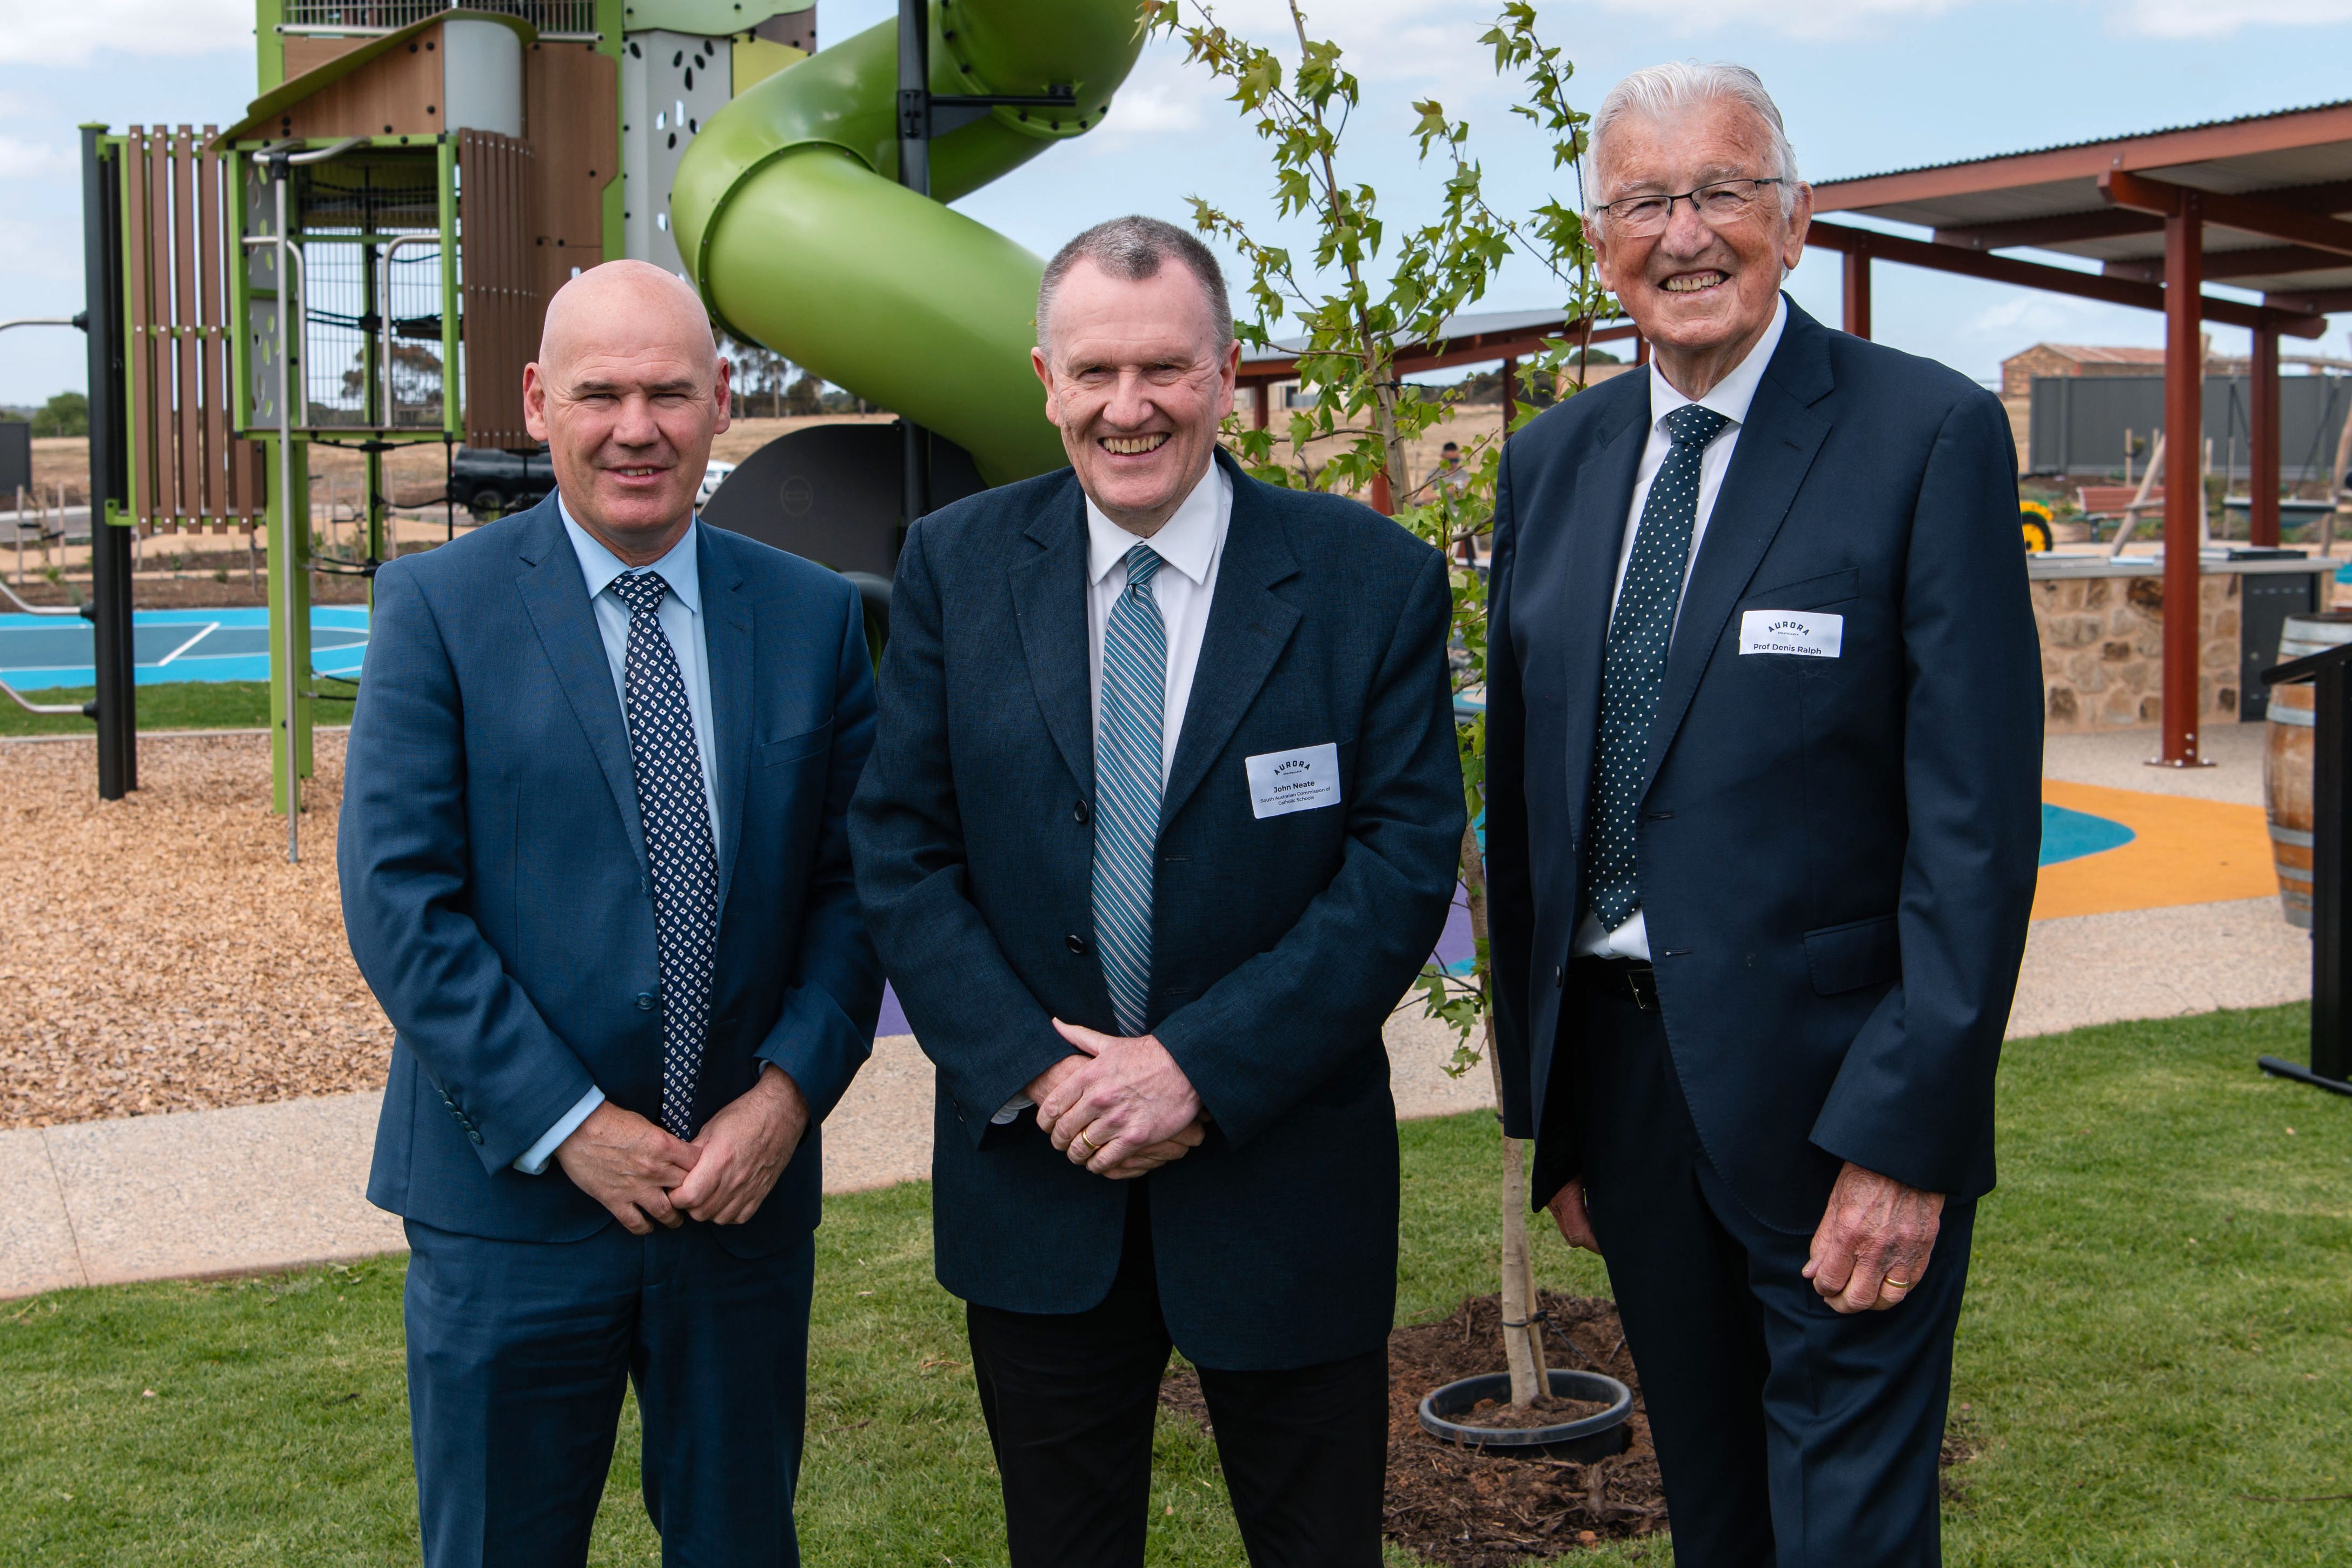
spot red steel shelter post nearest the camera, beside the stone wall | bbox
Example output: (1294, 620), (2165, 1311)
(2157, 190), (2206, 769)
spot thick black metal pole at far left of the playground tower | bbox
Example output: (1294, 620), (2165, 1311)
(82, 124), (139, 799)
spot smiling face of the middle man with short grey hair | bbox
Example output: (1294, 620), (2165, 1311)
(1030, 258), (1242, 539)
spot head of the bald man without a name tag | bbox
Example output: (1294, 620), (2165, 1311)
(522, 261), (727, 567)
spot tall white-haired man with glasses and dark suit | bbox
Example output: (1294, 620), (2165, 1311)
(1486, 66), (2042, 1568)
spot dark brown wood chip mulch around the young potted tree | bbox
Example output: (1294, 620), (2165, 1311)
(1160, 1291), (1665, 1568)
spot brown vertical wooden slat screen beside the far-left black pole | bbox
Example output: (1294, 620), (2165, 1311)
(122, 124), (263, 529)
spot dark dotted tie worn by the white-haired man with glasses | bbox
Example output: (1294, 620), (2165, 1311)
(1585, 402), (1731, 931)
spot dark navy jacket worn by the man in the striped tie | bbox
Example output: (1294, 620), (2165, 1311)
(852, 456), (1463, 1371)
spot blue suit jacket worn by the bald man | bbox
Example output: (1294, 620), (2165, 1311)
(336, 496), (882, 1255)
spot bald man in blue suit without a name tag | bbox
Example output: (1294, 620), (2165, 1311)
(338, 261), (882, 1568)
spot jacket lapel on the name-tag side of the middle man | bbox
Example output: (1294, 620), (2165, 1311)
(1160, 451), (1298, 825)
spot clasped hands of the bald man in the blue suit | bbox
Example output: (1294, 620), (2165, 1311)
(555, 1065), (809, 1237)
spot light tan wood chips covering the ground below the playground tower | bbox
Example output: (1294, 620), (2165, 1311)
(0, 734), (390, 1128)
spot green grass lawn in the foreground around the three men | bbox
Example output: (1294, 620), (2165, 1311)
(0, 1006), (2352, 1568)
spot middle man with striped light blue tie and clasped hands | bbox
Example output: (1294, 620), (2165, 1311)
(852, 218), (1463, 1568)
